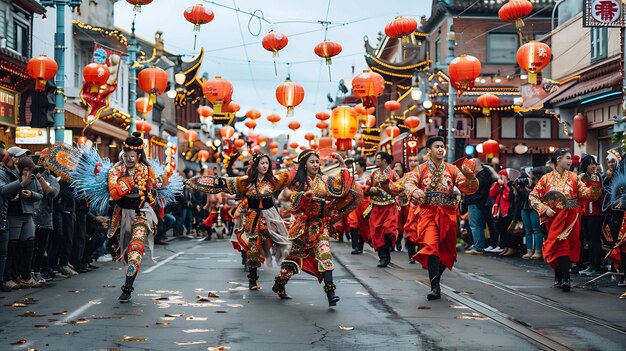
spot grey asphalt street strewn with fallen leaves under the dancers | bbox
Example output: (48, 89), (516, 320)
(0, 239), (626, 351)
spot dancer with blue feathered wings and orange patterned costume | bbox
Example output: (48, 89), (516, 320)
(44, 135), (183, 302)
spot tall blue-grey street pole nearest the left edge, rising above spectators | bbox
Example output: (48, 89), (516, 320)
(40, 0), (83, 143)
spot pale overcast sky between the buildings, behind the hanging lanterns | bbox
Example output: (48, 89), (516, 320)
(115, 0), (431, 143)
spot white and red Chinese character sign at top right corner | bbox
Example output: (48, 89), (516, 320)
(583, 0), (626, 27)
